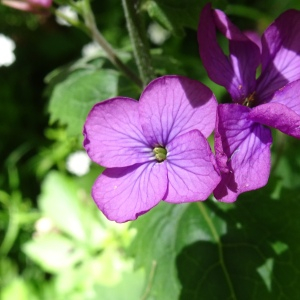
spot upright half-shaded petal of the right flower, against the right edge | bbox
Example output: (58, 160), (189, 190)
(257, 10), (300, 103)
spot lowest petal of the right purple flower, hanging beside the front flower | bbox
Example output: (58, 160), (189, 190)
(214, 104), (272, 202)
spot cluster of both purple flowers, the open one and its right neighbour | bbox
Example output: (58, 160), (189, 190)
(84, 4), (300, 222)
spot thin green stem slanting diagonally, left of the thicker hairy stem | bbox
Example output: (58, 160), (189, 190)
(83, 1), (143, 88)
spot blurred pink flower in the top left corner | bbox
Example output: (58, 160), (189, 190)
(1, 0), (52, 13)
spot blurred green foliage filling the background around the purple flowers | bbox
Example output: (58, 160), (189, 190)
(0, 0), (300, 300)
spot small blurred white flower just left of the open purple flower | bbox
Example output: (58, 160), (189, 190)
(66, 151), (91, 176)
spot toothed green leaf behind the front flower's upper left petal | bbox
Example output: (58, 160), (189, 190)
(49, 69), (119, 135)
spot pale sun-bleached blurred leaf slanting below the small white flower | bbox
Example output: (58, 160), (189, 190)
(39, 171), (106, 249)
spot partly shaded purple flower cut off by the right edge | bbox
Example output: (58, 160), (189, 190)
(198, 5), (300, 202)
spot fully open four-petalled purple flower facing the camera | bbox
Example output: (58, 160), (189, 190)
(84, 76), (220, 222)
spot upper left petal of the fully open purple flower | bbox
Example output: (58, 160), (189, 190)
(84, 97), (154, 167)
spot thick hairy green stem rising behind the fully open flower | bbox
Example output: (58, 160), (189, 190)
(122, 0), (155, 86)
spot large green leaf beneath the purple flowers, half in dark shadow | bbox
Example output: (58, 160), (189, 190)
(130, 182), (300, 300)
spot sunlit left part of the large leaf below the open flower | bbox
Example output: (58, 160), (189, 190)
(130, 202), (226, 299)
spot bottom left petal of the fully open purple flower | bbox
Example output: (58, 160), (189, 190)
(92, 162), (167, 223)
